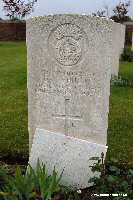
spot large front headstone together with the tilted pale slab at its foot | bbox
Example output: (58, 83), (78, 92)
(27, 14), (114, 188)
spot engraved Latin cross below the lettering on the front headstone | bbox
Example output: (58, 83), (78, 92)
(53, 97), (82, 136)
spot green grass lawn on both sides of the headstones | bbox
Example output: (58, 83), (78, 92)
(0, 42), (133, 165)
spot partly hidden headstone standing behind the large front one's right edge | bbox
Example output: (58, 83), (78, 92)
(111, 23), (125, 76)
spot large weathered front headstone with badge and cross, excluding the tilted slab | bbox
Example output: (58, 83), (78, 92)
(27, 14), (114, 151)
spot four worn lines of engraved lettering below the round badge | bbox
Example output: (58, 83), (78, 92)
(35, 70), (99, 96)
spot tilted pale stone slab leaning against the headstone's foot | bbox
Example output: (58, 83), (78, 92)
(29, 129), (107, 189)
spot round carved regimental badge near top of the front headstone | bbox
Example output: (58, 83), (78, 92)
(48, 24), (88, 66)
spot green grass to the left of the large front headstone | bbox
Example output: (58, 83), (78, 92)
(0, 42), (28, 160)
